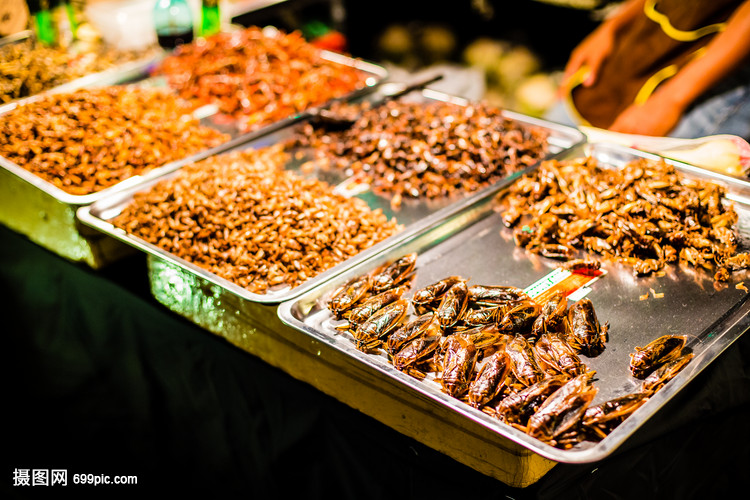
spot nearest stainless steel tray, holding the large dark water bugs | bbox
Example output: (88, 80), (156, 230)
(278, 144), (750, 463)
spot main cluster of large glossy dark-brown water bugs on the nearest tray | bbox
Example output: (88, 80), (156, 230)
(327, 253), (648, 448)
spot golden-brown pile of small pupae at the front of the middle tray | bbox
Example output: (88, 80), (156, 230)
(112, 145), (402, 293)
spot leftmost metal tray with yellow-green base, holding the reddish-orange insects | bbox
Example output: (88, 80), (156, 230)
(0, 28), (387, 268)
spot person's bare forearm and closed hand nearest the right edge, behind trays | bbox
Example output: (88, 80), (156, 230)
(609, 0), (750, 136)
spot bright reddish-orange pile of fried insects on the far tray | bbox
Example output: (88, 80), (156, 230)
(160, 26), (367, 131)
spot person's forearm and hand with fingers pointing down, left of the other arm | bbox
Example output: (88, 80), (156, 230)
(562, 0), (645, 90)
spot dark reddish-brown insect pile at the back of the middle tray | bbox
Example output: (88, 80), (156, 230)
(292, 100), (547, 208)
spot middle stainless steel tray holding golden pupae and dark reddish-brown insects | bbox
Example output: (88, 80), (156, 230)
(78, 91), (583, 304)
